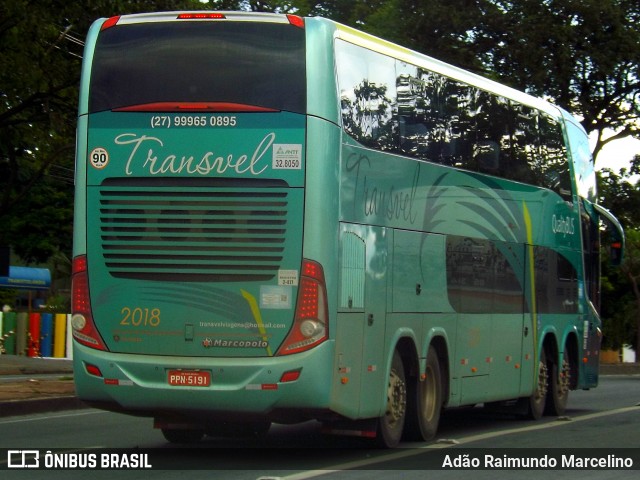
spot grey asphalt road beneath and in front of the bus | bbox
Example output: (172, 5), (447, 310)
(0, 376), (640, 480)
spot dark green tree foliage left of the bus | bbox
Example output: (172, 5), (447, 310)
(0, 0), (199, 262)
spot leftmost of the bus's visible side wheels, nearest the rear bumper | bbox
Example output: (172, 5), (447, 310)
(376, 350), (407, 448)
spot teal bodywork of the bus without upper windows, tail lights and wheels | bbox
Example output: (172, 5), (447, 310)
(74, 14), (624, 442)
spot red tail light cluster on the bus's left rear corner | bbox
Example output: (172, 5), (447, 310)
(71, 255), (107, 350)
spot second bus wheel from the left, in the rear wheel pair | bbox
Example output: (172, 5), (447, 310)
(417, 347), (442, 440)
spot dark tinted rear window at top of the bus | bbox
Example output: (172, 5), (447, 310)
(89, 22), (306, 113)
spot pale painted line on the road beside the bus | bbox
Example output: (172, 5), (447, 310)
(272, 406), (638, 480)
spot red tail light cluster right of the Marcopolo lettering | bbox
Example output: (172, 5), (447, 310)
(278, 260), (329, 355)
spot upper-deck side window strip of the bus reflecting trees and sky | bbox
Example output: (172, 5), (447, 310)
(336, 42), (571, 199)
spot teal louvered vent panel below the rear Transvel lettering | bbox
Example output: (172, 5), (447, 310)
(100, 179), (289, 282)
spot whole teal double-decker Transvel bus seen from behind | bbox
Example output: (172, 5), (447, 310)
(72, 12), (623, 446)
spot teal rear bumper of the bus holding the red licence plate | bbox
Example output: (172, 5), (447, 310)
(74, 342), (333, 421)
